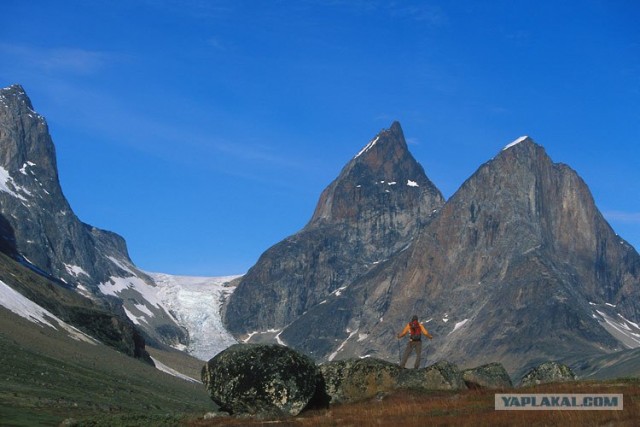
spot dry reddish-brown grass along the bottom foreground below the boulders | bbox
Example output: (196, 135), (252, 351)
(190, 380), (640, 427)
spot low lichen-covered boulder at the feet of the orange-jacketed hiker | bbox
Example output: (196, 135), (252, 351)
(398, 361), (467, 390)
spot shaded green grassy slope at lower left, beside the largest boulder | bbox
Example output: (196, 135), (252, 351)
(0, 307), (214, 425)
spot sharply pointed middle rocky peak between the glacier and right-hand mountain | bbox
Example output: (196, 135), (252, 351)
(223, 122), (444, 347)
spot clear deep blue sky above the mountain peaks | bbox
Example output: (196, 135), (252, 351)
(0, 0), (640, 275)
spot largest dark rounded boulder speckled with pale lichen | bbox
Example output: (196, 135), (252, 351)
(202, 344), (318, 416)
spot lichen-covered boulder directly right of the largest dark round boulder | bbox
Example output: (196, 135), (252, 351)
(319, 358), (400, 404)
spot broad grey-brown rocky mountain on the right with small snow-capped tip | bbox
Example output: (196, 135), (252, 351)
(330, 138), (640, 376)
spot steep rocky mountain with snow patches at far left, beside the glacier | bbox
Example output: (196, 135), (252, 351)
(0, 85), (188, 345)
